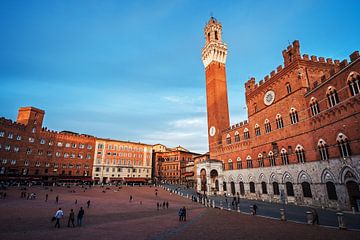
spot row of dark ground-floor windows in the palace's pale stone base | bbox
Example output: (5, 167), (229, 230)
(223, 182), (338, 200)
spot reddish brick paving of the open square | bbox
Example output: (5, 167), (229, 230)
(0, 186), (360, 240)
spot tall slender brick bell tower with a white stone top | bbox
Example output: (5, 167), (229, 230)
(202, 17), (230, 158)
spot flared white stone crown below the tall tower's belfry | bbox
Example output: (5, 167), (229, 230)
(201, 41), (227, 68)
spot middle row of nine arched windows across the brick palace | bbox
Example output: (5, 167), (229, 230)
(228, 133), (351, 170)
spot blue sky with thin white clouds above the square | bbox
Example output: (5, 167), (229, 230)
(0, 0), (360, 152)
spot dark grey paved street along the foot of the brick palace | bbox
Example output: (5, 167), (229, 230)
(161, 185), (360, 231)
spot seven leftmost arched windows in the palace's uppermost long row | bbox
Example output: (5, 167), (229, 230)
(226, 108), (299, 144)
